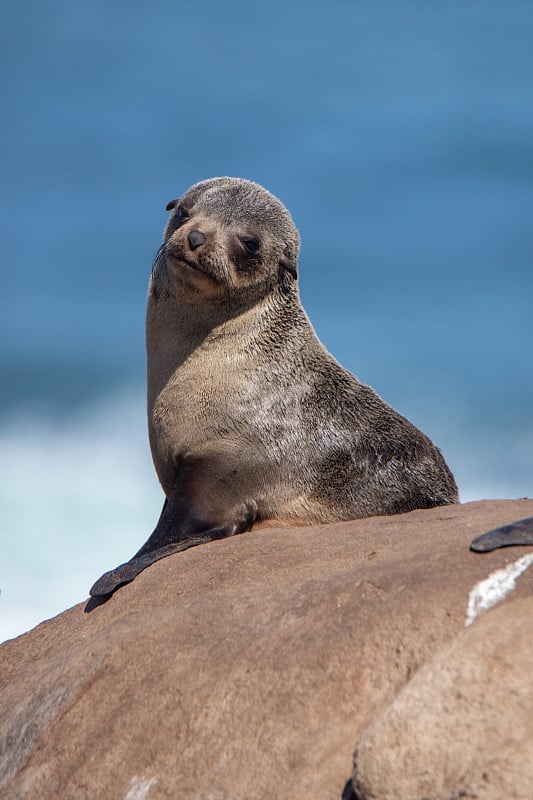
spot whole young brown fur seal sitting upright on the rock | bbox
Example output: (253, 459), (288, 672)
(90, 178), (458, 597)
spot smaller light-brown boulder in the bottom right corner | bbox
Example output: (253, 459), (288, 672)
(354, 596), (533, 800)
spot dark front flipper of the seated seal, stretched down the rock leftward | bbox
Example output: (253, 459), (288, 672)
(89, 520), (239, 597)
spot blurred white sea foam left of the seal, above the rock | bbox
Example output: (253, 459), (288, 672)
(0, 392), (163, 641)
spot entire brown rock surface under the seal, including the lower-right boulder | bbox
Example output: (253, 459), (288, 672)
(0, 500), (533, 800)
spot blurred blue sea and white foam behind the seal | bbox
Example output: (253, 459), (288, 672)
(0, 0), (533, 640)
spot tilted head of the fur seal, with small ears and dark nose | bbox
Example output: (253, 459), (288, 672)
(159, 178), (300, 303)
